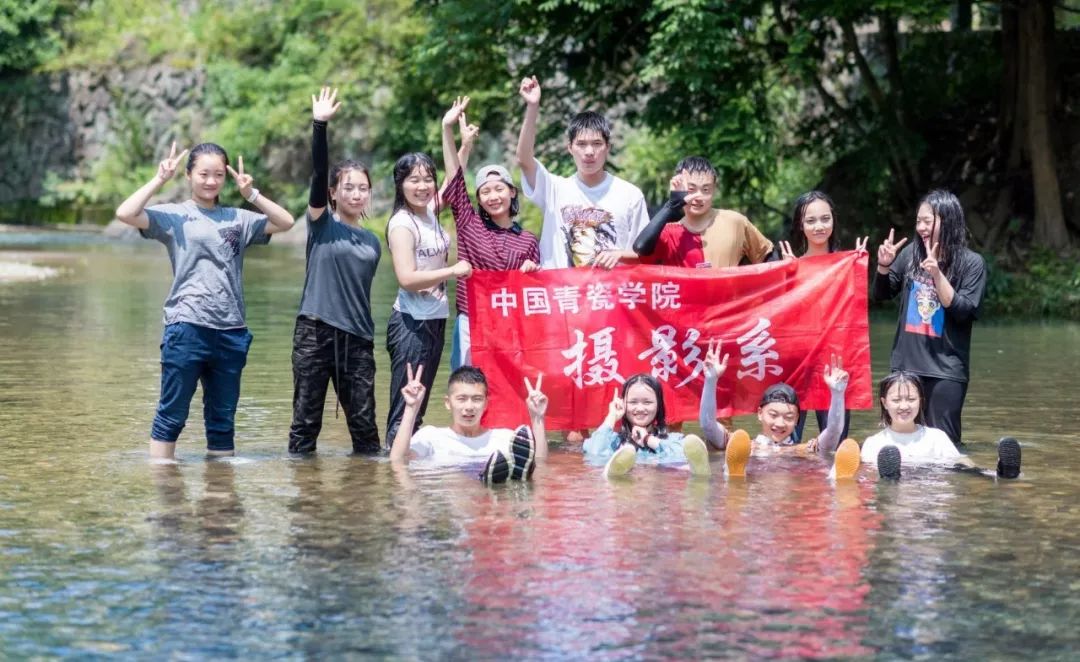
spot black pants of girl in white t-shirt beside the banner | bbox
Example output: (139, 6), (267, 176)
(387, 310), (446, 446)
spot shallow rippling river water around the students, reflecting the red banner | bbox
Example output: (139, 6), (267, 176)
(0, 232), (1080, 660)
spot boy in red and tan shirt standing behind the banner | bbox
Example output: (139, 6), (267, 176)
(634, 157), (772, 269)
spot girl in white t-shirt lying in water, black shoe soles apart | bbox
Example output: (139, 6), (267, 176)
(861, 370), (1021, 478)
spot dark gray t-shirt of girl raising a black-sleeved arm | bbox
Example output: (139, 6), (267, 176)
(300, 207), (382, 341)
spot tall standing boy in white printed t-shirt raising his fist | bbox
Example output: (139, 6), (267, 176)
(517, 77), (649, 269)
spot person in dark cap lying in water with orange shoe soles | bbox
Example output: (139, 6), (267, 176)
(699, 341), (859, 478)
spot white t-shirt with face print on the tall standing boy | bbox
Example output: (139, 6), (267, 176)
(522, 161), (649, 269)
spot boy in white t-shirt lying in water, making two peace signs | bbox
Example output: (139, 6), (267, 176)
(390, 365), (548, 484)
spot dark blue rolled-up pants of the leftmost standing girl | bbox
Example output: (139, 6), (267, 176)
(150, 322), (252, 450)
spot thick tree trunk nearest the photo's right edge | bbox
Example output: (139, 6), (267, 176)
(1018, 0), (1069, 251)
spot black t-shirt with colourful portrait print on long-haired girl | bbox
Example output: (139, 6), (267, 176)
(874, 244), (986, 381)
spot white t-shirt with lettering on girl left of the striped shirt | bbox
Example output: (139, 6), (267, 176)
(387, 208), (450, 320)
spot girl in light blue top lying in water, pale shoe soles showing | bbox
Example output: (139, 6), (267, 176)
(581, 373), (710, 477)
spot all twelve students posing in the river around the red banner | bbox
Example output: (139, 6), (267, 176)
(117, 77), (1018, 481)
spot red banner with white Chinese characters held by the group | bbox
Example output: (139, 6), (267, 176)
(469, 251), (873, 430)
